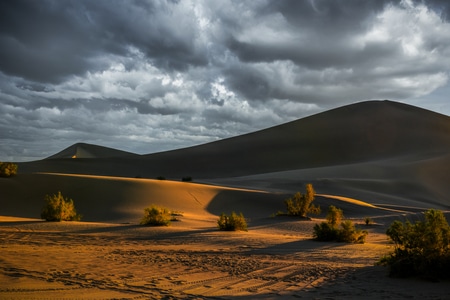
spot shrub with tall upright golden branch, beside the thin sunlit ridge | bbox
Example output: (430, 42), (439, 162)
(284, 183), (320, 218)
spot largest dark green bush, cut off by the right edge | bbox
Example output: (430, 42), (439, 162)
(380, 209), (450, 280)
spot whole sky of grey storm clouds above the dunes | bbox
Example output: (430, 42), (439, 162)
(0, 0), (450, 161)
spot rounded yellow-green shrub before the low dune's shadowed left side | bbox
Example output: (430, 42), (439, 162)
(41, 192), (81, 222)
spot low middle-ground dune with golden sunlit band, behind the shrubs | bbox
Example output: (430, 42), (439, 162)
(0, 174), (400, 223)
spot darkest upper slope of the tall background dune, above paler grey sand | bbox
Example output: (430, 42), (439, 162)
(20, 101), (450, 179)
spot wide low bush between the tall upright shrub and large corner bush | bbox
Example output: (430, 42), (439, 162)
(313, 206), (367, 244)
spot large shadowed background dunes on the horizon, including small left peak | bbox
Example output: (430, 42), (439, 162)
(15, 101), (450, 212)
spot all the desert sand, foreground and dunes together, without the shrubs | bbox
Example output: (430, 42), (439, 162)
(0, 101), (450, 299)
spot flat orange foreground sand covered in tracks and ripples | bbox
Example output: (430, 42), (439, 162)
(0, 214), (450, 299)
